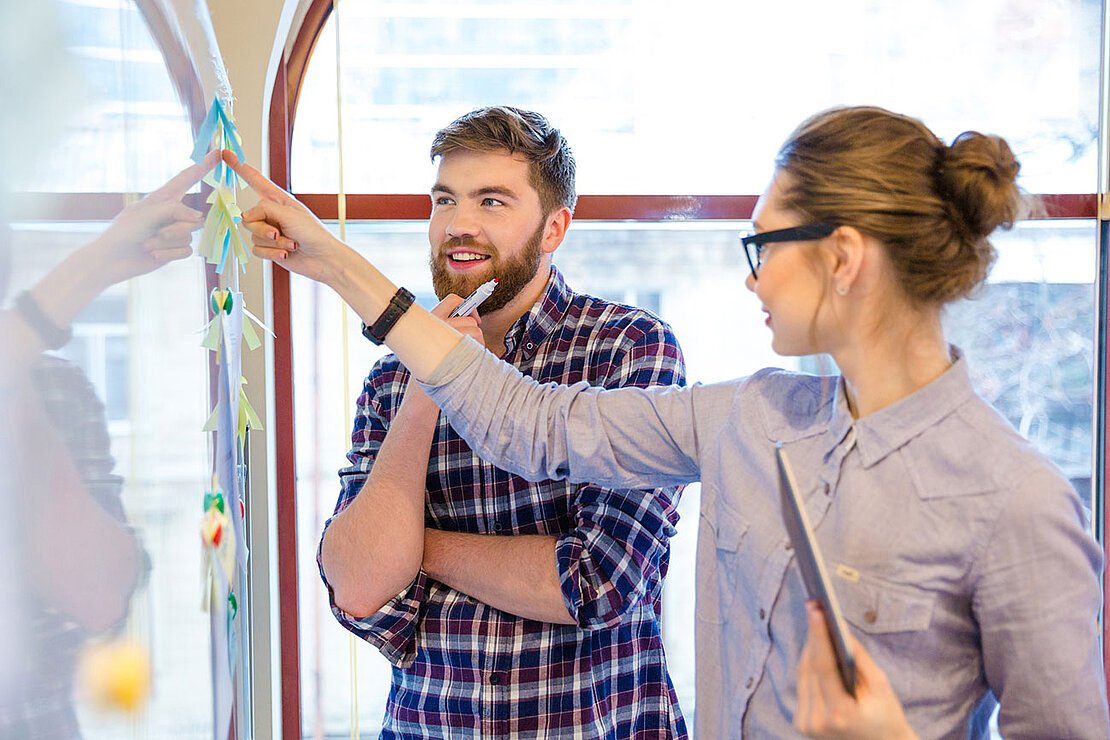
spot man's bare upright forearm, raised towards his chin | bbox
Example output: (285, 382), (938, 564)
(321, 385), (438, 618)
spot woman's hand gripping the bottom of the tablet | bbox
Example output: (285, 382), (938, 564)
(794, 601), (917, 740)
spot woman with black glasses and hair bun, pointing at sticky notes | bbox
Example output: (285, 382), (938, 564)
(229, 108), (1110, 739)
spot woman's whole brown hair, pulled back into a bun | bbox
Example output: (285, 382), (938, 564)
(775, 107), (1035, 304)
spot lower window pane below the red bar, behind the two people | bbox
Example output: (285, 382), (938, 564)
(293, 221), (1096, 737)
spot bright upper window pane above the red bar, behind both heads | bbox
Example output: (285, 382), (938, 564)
(291, 0), (1101, 194)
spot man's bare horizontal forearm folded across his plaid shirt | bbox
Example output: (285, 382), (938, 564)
(424, 529), (576, 625)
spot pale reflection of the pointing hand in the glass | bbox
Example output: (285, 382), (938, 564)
(89, 151), (220, 290)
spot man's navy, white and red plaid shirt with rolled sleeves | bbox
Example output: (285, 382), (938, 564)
(321, 268), (686, 740)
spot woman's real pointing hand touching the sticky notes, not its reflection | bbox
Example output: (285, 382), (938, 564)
(223, 150), (350, 284)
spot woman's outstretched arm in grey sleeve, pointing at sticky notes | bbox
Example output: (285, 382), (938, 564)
(223, 151), (705, 488)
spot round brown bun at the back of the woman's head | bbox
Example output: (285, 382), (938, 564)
(937, 131), (1028, 241)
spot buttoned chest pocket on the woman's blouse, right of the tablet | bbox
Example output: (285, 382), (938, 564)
(830, 566), (937, 635)
